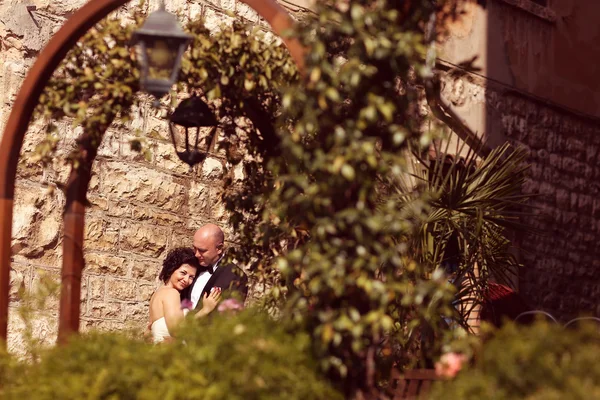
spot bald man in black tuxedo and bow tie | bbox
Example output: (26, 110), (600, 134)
(184, 224), (248, 310)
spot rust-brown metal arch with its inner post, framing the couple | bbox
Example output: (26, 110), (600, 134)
(0, 0), (304, 346)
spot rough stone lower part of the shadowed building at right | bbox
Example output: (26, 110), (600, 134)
(443, 74), (600, 320)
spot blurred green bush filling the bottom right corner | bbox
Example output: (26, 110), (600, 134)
(432, 323), (600, 400)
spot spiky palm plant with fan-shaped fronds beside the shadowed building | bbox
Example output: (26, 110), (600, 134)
(395, 141), (530, 328)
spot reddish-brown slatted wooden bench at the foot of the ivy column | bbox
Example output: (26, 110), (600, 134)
(389, 368), (443, 400)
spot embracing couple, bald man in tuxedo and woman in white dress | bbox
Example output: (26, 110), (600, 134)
(149, 224), (248, 343)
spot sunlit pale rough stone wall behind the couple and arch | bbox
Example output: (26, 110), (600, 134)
(0, 0), (294, 352)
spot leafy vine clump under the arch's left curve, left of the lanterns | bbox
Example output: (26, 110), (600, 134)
(33, 14), (139, 168)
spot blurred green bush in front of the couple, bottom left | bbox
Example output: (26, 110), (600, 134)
(0, 311), (340, 400)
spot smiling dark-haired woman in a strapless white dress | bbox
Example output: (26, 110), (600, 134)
(150, 247), (221, 343)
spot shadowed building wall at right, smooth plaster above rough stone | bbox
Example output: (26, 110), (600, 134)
(438, 0), (600, 319)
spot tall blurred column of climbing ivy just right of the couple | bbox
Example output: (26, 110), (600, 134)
(220, 1), (468, 398)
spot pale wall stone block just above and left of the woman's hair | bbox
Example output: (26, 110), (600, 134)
(121, 221), (169, 259)
